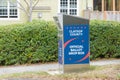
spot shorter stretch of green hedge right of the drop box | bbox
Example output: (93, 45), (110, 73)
(90, 21), (120, 59)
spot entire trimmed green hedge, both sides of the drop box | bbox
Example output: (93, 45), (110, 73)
(0, 21), (120, 65)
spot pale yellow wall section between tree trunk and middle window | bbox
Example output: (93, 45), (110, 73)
(32, 0), (58, 20)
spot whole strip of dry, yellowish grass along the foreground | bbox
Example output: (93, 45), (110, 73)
(0, 65), (120, 80)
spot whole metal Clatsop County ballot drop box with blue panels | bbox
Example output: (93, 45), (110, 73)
(54, 14), (90, 73)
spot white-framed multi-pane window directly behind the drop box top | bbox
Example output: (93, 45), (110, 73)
(60, 0), (78, 15)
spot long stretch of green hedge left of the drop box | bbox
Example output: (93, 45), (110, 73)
(0, 21), (57, 65)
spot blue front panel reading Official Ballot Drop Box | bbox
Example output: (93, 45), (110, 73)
(63, 24), (90, 64)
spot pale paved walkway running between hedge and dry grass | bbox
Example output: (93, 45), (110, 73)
(0, 59), (120, 75)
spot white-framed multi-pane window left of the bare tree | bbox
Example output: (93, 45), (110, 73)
(0, 0), (18, 18)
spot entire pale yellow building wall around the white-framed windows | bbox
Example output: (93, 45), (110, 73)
(0, 0), (93, 25)
